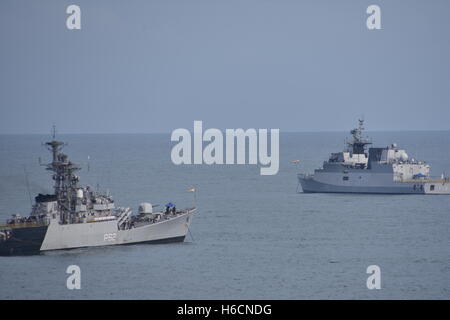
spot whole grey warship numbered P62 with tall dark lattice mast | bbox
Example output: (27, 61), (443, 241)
(0, 135), (196, 255)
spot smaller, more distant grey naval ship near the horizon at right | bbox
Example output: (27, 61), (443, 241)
(298, 120), (450, 194)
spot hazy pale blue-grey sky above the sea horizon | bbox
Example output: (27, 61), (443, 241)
(0, 0), (450, 133)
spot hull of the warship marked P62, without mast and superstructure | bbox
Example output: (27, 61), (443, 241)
(0, 210), (195, 255)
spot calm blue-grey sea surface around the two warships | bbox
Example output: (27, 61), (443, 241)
(0, 131), (450, 299)
